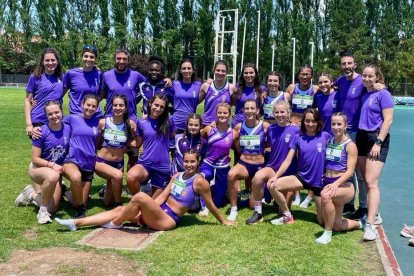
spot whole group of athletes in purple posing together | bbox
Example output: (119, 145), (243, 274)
(16, 45), (400, 244)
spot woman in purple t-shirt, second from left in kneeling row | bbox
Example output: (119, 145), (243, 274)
(63, 94), (99, 217)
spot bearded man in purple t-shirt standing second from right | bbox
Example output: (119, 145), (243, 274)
(334, 53), (367, 219)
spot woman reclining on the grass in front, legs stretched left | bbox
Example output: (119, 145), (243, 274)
(56, 150), (233, 231)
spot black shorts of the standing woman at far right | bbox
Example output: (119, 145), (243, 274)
(355, 129), (390, 163)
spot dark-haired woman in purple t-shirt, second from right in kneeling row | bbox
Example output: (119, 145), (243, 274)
(267, 108), (330, 225)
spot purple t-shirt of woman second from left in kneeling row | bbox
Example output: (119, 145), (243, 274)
(64, 113), (99, 172)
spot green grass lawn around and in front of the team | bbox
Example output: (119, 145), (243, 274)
(0, 88), (383, 275)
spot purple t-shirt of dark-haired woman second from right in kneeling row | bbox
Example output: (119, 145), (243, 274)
(289, 131), (331, 188)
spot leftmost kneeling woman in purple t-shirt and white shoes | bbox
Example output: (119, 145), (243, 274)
(15, 101), (70, 224)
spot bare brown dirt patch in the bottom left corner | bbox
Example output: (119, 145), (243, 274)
(0, 248), (145, 276)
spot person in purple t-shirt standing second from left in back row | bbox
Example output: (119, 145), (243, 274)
(63, 45), (102, 114)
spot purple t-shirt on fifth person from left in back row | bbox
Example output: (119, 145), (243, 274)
(170, 81), (201, 130)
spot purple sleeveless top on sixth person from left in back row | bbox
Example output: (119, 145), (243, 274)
(202, 82), (230, 126)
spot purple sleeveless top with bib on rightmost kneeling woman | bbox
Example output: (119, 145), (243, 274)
(325, 137), (351, 172)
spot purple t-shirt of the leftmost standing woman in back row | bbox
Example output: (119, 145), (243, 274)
(26, 73), (63, 124)
